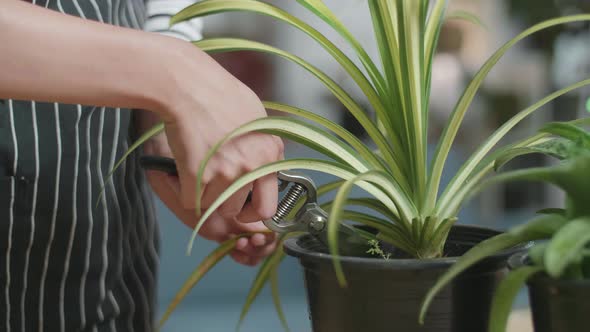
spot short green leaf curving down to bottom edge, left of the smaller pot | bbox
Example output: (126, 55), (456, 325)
(488, 266), (542, 332)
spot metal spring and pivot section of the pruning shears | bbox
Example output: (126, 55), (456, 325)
(264, 171), (328, 234)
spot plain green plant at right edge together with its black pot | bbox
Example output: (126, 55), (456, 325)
(425, 119), (590, 332)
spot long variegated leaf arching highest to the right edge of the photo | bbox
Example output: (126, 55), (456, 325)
(427, 15), (590, 211)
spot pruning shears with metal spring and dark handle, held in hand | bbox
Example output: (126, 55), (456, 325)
(140, 156), (366, 252)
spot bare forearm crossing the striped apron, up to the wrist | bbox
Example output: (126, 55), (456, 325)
(0, 0), (188, 116)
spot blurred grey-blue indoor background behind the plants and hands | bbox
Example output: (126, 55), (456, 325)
(158, 0), (590, 332)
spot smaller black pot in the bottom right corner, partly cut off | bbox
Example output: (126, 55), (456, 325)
(509, 253), (590, 332)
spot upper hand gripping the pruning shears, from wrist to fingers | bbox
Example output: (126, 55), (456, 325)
(158, 41), (283, 223)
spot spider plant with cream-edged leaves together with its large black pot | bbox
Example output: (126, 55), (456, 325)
(112, 0), (590, 331)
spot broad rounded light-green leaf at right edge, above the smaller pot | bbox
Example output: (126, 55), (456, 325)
(545, 217), (590, 278)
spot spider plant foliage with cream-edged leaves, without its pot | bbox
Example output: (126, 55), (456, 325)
(113, 0), (590, 328)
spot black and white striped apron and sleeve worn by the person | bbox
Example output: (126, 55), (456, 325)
(0, 0), (200, 332)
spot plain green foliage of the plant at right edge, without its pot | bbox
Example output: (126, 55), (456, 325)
(428, 119), (590, 332)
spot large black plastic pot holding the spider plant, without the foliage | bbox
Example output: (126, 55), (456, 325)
(285, 226), (525, 332)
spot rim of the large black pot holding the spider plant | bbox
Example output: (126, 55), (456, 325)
(283, 225), (533, 269)
